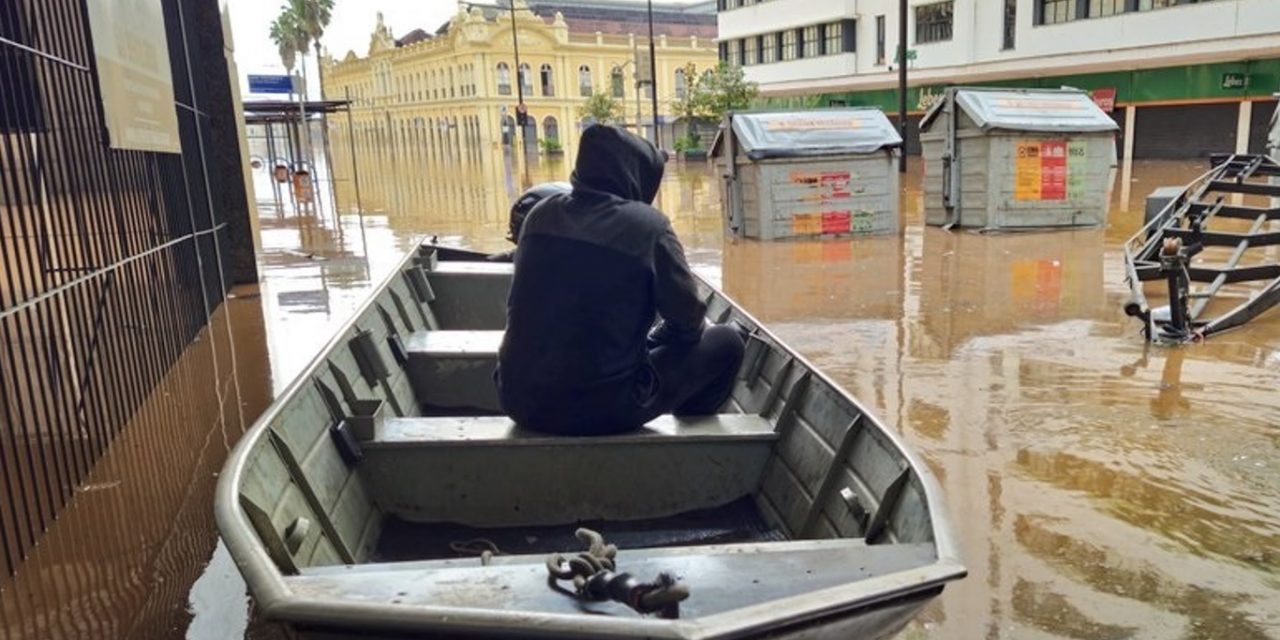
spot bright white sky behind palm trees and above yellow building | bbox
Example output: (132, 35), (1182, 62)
(223, 0), (689, 100)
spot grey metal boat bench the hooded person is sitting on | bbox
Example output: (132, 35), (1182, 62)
(361, 413), (777, 526)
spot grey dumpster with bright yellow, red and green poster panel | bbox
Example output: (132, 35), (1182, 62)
(920, 87), (1119, 229)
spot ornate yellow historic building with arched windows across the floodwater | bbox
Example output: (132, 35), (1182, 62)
(324, 0), (717, 154)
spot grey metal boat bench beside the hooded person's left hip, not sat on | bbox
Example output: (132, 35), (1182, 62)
(404, 330), (503, 413)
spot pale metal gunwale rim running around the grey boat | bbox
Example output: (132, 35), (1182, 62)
(214, 241), (968, 639)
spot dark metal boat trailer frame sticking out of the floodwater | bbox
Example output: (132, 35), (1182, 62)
(1124, 155), (1280, 344)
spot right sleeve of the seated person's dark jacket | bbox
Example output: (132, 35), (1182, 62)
(649, 225), (707, 346)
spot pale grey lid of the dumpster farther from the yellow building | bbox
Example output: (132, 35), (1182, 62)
(920, 87), (1120, 132)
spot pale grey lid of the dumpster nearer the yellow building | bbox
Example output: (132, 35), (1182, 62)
(712, 108), (902, 160)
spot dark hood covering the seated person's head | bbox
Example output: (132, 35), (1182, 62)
(570, 124), (667, 205)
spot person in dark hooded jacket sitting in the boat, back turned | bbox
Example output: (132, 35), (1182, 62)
(494, 124), (744, 435)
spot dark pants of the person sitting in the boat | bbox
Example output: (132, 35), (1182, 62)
(503, 326), (746, 435)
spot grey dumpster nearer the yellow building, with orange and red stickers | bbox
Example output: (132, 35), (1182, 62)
(712, 109), (902, 239)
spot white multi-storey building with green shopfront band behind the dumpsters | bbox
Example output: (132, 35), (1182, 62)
(717, 0), (1280, 157)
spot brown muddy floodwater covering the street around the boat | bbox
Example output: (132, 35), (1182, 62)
(0, 147), (1280, 640)
